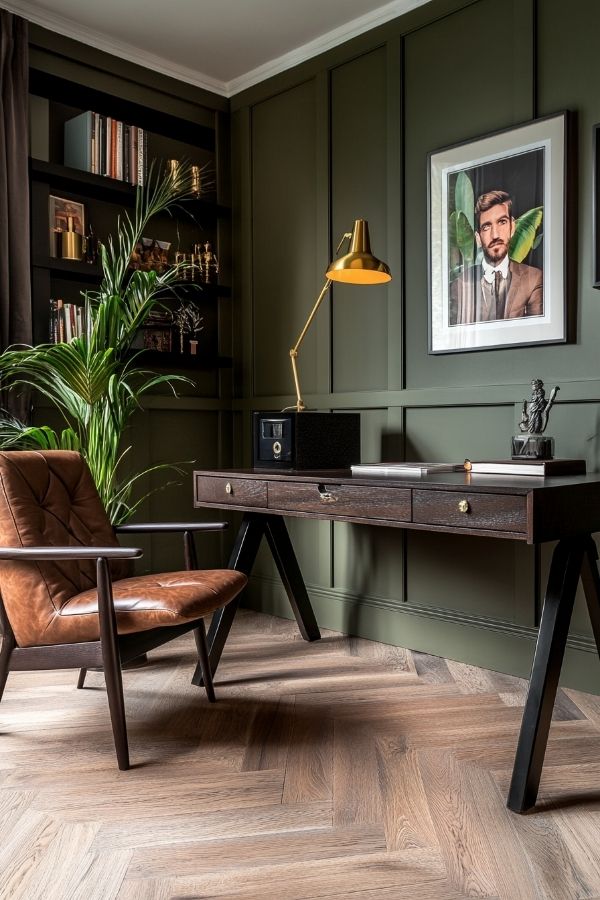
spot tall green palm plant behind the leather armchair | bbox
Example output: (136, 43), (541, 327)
(0, 165), (202, 525)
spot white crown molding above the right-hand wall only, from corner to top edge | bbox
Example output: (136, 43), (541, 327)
(225, 0), (429, 97)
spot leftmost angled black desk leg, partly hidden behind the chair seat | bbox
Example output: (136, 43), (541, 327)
(192, 513), (265, 687)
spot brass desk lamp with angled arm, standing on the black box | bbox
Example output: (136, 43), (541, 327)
(284, 219), (392, 412)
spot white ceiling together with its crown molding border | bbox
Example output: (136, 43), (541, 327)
(0, 0), (428, 97)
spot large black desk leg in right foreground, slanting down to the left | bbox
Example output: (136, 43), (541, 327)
(507, 536), (591, 813)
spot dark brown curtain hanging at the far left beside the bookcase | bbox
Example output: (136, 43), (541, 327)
(0, 10), (32, 420)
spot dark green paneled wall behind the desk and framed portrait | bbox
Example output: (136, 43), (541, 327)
(232, 0), (600, 690)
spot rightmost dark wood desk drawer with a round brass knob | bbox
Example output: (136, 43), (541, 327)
(413, 490), (527, 533)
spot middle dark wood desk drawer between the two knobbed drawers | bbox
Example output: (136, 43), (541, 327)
(269, 482), (410, 522)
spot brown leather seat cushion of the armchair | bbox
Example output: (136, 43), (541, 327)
(40, 569), (248, 644)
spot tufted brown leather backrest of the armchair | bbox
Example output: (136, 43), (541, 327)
(0, 450), (129, 646)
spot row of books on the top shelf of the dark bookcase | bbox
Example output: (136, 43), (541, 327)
(64, 110), (148, 185)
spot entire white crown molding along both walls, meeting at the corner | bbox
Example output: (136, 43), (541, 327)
(0, 0), (429, 97)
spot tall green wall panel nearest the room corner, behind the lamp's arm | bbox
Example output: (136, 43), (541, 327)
(251, 81), (327, 395)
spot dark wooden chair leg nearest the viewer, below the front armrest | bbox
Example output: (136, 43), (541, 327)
(96, 559), (129, 769)
